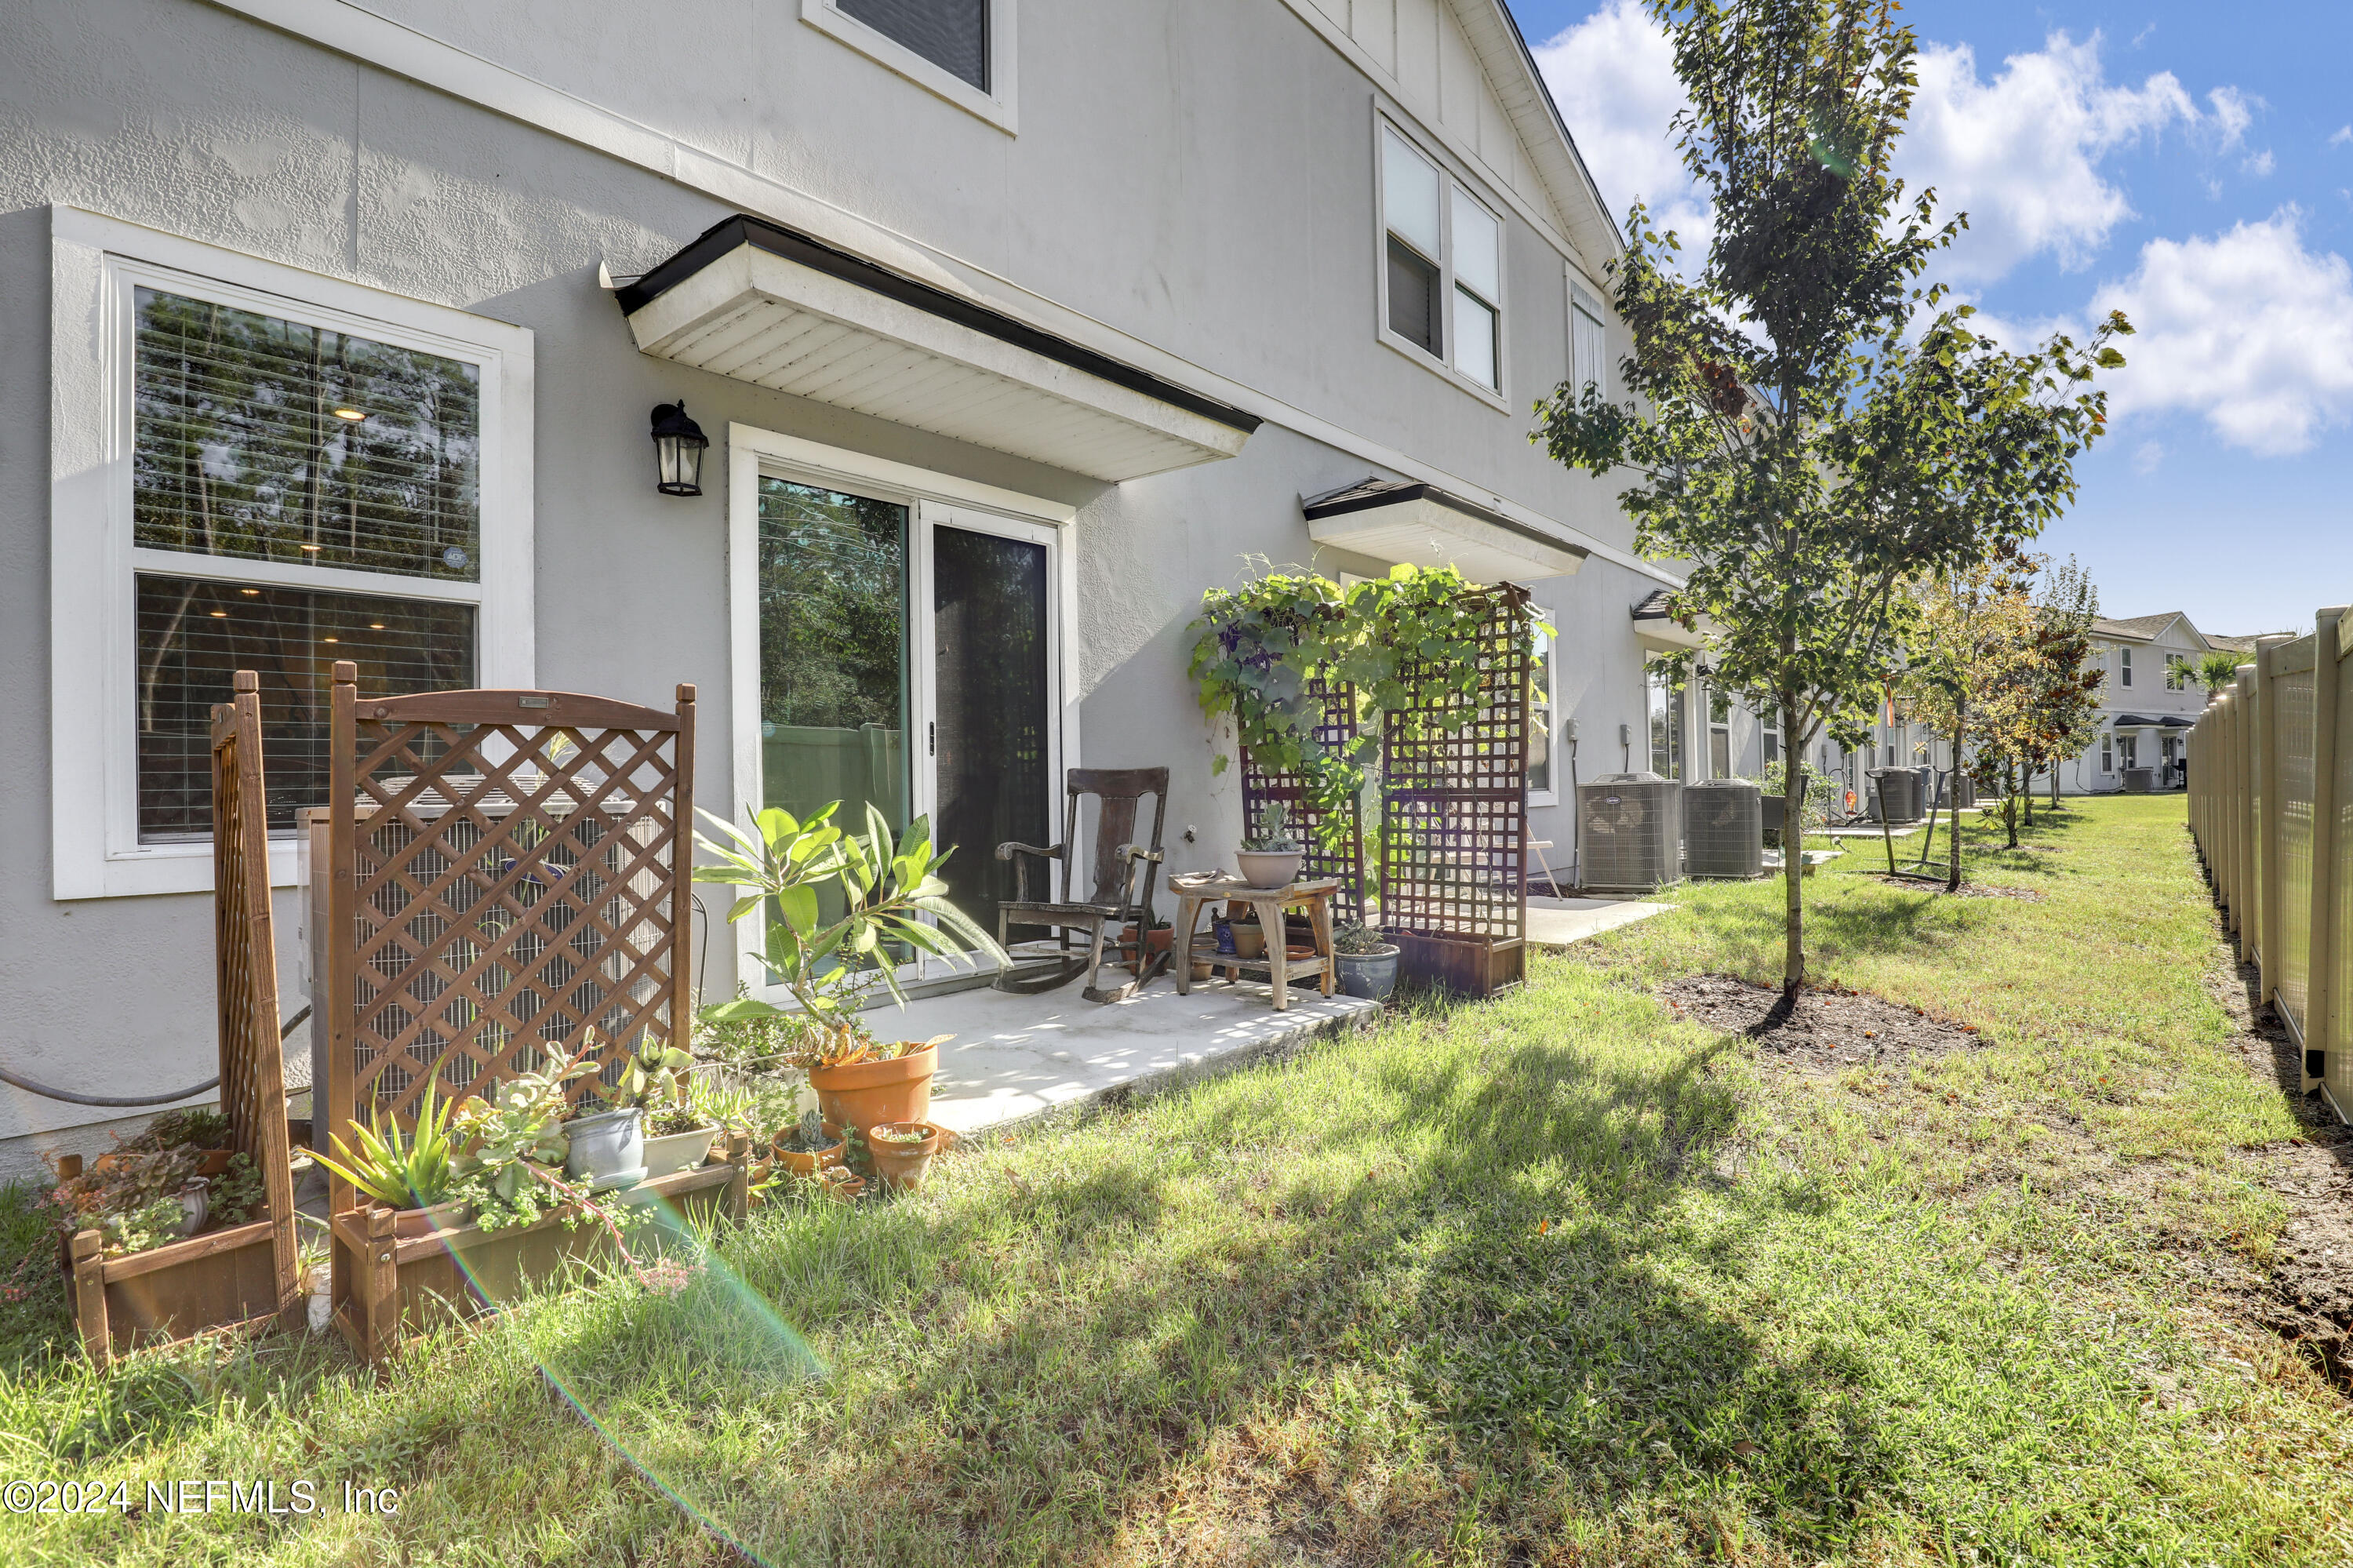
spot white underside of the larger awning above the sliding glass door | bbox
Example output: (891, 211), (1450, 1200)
(628, 245), (1249, 482)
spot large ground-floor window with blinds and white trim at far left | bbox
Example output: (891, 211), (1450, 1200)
(52, 209), (532, 897)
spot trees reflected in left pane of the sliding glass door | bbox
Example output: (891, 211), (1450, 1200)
(760, 478), (906, 729)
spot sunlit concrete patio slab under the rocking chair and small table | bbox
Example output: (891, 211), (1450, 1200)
(889, 975), (1381, 1133)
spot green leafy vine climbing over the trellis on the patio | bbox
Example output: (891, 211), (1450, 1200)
(1188, 565), (1537, 850)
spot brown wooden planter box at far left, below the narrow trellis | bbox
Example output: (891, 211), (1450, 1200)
(68, 1220), (294, 1366)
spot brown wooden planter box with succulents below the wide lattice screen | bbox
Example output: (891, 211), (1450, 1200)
(334, 1163), (751, 1361)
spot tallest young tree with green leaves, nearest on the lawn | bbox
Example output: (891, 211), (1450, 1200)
(1537, 0), (2129, 999)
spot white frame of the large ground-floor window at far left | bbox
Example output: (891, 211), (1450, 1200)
(49, 207), (536, 900)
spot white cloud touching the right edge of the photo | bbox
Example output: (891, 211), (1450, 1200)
(2092, 207), (2353, 457)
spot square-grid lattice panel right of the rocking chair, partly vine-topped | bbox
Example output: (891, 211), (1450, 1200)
(1379, 584), (1534, 944)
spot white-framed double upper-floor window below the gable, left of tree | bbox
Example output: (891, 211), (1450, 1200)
(1381, 125), (1504, 393)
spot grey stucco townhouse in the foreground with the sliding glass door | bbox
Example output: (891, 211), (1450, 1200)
(0, 0), (1694, 1173)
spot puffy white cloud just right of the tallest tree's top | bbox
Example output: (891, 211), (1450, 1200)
(1897, 33), (2202, 282)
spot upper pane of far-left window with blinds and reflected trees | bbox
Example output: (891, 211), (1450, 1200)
(132, 287), (482, 581)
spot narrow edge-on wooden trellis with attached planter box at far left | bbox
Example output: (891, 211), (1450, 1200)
(61, 668), (301, 1366)
